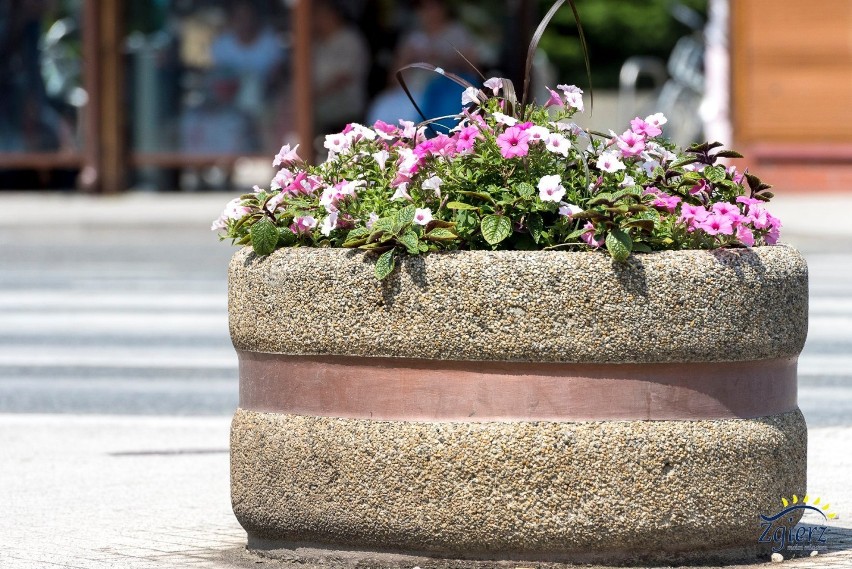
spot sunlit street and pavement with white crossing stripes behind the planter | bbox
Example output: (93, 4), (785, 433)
(0, 194), (852, 569)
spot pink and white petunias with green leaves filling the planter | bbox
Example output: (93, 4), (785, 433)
(213, 2), (781, 279)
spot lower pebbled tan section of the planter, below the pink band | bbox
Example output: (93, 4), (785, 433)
(231, 409), (807, 562)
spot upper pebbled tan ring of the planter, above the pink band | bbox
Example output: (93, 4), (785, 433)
(228, 245), (808, 363)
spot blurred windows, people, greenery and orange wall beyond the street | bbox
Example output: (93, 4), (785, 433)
(0, 0), (852, 193)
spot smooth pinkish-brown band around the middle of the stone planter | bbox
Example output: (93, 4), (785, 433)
(238, 351), (797, 421)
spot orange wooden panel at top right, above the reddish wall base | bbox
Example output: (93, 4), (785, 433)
(731, 0), (852, 145)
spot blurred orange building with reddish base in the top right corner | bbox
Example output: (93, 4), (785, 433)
(729, 0), (852, 191)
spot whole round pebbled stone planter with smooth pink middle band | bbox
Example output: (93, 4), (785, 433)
(228, 246), (808, 567)
